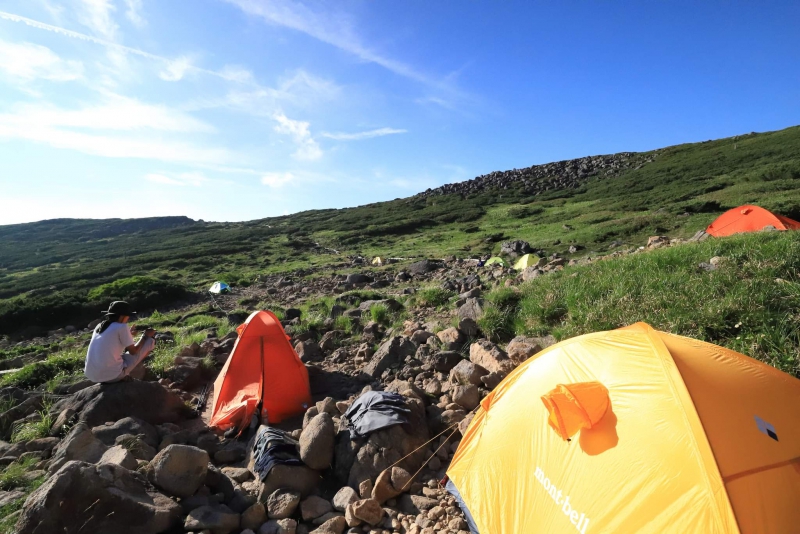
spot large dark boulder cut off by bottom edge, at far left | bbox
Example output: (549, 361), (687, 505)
(15, 461), (181, 534)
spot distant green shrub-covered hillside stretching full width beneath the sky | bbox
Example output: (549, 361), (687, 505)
(0, 127), (800, 335)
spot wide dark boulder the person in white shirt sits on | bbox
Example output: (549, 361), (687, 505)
(51, 380), (190, 428)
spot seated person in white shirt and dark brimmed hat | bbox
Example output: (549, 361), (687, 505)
(83, 300), (156, 383)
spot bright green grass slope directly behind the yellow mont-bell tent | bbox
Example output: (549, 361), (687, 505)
(500, 232), (800, 377)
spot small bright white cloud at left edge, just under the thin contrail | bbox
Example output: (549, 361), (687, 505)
(0, 39), (83, 82)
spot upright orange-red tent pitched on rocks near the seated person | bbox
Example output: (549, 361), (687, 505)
(209, 311), (311, 430)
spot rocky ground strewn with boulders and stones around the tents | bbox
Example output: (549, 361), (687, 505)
(0, 237), (713, 534)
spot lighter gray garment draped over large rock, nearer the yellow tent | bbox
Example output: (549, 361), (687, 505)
(344, 391), (411, 438)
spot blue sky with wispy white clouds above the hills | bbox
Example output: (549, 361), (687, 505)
(0, 0), (800, 224)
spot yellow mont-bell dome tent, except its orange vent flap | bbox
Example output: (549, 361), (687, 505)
(447, 323), (800, 534)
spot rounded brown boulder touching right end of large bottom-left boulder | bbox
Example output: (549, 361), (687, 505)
(150, 445), (209, 497)
